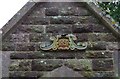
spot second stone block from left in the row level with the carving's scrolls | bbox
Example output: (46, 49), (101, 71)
(15, 43), (35, 51)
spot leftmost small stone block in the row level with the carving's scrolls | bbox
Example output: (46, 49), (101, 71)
(2, 42), (15, 51)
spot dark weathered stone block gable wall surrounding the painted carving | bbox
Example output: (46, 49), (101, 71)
(2, 3), (120, 77)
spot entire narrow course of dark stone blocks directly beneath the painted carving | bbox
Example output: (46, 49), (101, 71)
(10, 51), (114, 59)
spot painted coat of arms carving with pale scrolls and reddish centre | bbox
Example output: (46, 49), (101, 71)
(40, 34), (87, 50)
